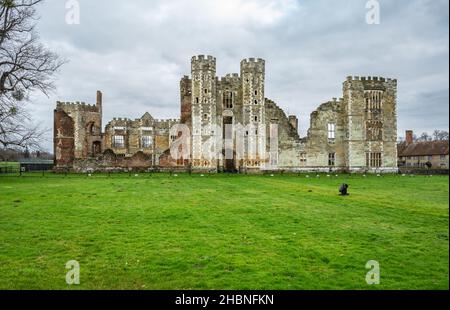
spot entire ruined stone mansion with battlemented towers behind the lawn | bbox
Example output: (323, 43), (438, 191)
(54, 55), (397, 173)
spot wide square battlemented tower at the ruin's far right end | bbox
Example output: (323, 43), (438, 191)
(344, 77), (397, 171)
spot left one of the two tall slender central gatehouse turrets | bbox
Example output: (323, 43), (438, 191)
(191, 55), (218, 169)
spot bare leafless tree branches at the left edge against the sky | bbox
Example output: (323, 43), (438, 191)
(0, 0), (65, 148)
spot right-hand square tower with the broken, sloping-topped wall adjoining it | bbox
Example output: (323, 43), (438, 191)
(305, 77), (397, 172)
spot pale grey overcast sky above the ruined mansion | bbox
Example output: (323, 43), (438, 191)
(30, 0), (449, 150)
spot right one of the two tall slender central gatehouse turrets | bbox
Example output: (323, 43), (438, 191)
(241, 58), (266, 168)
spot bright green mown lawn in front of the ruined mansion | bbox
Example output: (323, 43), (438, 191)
(0, 174), (449, 289)
